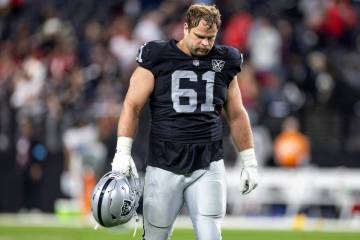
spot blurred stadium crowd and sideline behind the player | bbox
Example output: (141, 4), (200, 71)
(0, 0), (360, 239)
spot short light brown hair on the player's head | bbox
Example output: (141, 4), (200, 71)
(185, 4), (221, 30)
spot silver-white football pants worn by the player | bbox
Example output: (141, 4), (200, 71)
(143, 160), (226, 240)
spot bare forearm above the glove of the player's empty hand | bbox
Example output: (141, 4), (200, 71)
(229, 108), (254, 152)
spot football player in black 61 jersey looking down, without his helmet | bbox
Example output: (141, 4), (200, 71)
(112, 4), (258, 240)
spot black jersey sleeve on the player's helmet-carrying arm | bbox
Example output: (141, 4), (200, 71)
(136, 42), (159, 76)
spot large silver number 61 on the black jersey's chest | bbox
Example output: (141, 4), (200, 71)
(171, 70), (215, 112)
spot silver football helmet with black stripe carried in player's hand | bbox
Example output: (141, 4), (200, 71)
(91, 172), (141, 227)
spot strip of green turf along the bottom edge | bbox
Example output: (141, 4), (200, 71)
(0, 226), (360, 240)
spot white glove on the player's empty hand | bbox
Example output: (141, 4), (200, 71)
(239, 148), (258, 195)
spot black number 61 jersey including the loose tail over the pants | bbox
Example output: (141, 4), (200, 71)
(137, 40), (242, 174)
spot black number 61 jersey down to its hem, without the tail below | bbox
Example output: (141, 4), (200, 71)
(137, 40), (242, 143)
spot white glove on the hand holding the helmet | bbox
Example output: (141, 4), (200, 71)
(111, 137), (139, 178)
